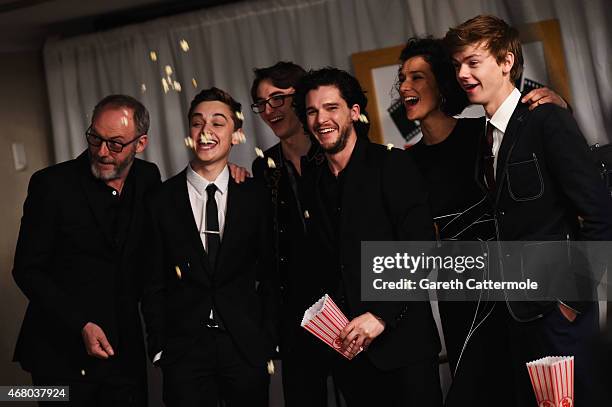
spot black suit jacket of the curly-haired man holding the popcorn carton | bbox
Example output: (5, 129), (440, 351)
(303, 137), (440, 370)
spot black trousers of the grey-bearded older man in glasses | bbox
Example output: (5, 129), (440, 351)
(32, 366), (147, 407)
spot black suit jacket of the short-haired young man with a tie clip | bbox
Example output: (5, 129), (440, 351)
(142, 171), (278, 366)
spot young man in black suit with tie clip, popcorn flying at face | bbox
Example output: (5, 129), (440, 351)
(143, 88), (278, 407)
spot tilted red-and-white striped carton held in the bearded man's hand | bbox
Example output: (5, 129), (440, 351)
(301, 294), (361, 360)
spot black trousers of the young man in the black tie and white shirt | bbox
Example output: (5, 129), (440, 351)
(162, 328), (270, 407)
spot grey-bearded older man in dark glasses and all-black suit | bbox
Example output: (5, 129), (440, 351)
(13, 95), (160, 406)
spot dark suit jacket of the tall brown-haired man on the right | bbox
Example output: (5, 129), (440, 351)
(477, 103), (612, 318)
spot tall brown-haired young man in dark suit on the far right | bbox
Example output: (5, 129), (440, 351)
(445, 16), (612, 406)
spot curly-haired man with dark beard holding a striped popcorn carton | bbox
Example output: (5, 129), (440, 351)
(294, 68), (442, 407)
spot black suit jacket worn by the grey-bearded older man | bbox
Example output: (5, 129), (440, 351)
(13, 152), (160, 378)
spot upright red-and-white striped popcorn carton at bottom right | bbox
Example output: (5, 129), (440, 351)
(527, 356), (574, 407)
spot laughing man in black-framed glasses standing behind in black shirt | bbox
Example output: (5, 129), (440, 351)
(251, 62), (327, 407)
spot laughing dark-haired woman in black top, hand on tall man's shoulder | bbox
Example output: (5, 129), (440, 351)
(398, 38), (567, 406)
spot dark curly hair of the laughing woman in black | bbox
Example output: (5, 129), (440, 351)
(396, 37), (470, 116)
